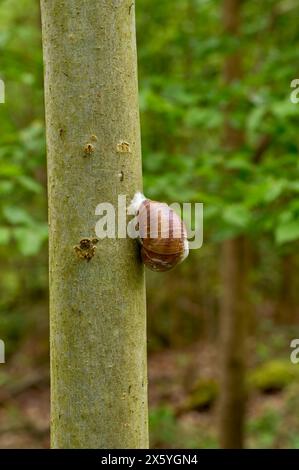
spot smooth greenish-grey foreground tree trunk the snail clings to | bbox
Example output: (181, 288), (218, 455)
(41, 0), (148, 448)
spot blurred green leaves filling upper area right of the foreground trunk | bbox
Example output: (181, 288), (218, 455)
(137, 0), (299, 245)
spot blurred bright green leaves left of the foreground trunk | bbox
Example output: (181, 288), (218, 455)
(0, 0), (47, 256)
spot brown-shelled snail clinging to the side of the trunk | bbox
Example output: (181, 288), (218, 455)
(129, 192), (189, 272)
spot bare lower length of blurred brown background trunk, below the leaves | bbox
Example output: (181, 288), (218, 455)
(219, 237), (248, 449)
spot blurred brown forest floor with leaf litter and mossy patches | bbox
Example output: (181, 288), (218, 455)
(0, 336), (299, 448)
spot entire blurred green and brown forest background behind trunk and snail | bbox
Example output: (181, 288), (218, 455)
(0, 0), (299, 448)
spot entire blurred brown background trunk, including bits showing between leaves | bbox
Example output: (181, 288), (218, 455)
(219, 0), (248, 448)
